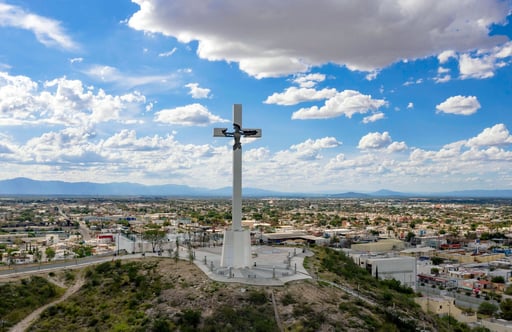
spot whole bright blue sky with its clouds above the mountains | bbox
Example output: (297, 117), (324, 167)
(0, 0), (512, 193)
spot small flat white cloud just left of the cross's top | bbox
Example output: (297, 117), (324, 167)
(155, 103), (230, 127)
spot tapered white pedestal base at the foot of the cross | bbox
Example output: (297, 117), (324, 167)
(220, 229), (252, 269)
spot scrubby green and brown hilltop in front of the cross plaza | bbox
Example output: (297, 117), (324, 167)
(0, 248), (482, 331)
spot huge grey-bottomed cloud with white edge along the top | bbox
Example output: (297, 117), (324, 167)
(128, 0), (509, 78)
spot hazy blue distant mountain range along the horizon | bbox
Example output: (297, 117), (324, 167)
(0, 178), (512, 199)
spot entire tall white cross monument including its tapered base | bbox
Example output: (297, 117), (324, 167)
(213, 104), (261, 268)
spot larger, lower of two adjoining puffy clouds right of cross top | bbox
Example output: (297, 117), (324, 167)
(292, 90), (387, 120)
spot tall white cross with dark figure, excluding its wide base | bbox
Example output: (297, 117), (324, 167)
(213, 104), (261, 231)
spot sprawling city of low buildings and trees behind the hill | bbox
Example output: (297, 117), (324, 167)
(0, 197), (512, 326)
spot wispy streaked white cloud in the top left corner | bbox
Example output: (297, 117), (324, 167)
(0, 3), (78, 50)
